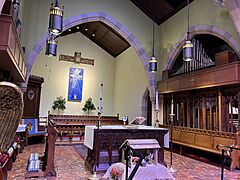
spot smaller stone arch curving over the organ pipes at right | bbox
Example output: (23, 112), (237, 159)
(164, 25), (240, 70)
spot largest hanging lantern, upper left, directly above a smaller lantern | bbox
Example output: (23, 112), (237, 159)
(48, 0), (63, 35)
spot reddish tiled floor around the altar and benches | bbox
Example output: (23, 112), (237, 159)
(8, 144), (240, 180)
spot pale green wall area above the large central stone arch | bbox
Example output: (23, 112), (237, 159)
(23, 0), (152, 62)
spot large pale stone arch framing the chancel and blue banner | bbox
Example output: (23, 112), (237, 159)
(27, 12), (157, 100)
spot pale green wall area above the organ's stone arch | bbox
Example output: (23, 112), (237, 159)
(157, 0), (240, 80)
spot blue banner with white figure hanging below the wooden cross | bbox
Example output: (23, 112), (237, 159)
(68, 67), (83, 101)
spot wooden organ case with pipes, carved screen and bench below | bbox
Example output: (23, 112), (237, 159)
(158, 34), (240, 169)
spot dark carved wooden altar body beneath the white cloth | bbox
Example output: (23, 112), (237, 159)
(86, 129), (168, 168)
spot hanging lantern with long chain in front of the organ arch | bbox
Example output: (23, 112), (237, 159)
(183, 0), (193, 61)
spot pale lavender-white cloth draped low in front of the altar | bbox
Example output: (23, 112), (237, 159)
(102, 163), (175, 180)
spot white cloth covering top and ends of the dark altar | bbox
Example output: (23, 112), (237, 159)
(84, 125), (169, 149)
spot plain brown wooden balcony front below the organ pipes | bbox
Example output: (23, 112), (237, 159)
(158, 61), (240, 94)
